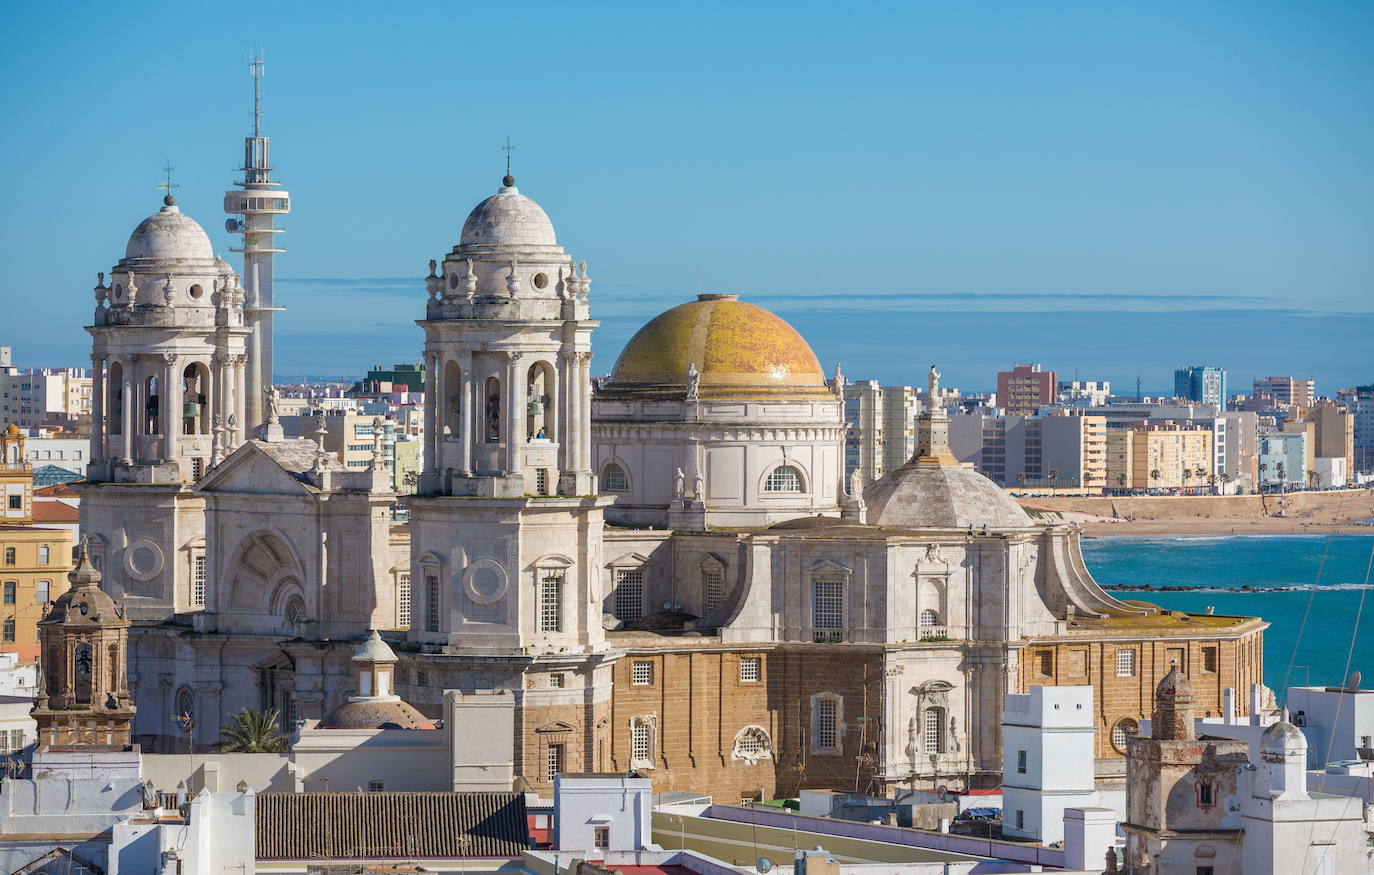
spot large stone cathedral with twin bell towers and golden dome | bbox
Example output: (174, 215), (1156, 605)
(69, 124), (1265, 801)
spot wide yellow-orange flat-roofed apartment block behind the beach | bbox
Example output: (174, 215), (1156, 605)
(1106, 422), (1213, 489)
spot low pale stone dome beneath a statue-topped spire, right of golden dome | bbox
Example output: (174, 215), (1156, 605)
(863, 460), (1035, 530)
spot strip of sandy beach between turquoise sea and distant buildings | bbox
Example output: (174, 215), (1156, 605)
(1021, 489), (1374, 537)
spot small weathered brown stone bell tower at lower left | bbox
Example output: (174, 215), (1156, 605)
(32, 541), (135, 750)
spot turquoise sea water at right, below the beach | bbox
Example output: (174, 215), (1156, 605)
(1083, 534), (1374, 699)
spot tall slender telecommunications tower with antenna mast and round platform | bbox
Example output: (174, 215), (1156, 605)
(224, 54), (291, 437)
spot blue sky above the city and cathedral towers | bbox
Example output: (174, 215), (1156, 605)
(0, 0), (1374, 391)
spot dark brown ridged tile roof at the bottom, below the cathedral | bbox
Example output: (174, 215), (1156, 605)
(256, 793), (529, 860)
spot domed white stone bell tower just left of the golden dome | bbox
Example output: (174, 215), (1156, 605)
(411, 172), (610, 654)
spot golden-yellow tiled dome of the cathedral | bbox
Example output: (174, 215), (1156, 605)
(602, 295), (834, 398)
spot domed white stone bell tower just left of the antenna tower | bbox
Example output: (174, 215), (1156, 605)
(77, 196), (251, 622)
